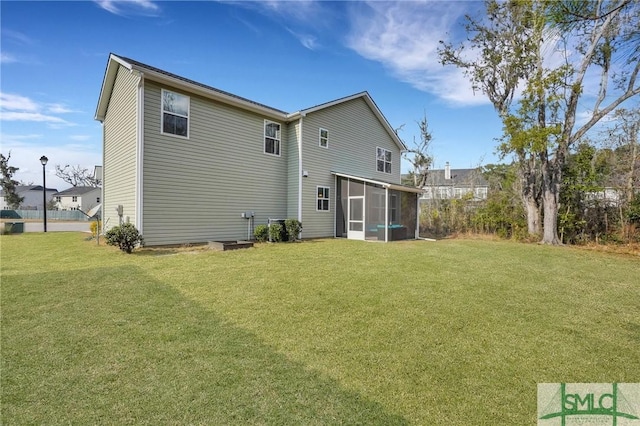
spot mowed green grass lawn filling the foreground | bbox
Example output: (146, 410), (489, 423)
(0, 233), (640, 425)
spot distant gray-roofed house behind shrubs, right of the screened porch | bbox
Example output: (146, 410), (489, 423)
(422, 162), (489, 201)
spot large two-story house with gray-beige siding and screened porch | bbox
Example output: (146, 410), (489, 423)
(96, 54), (422, 246)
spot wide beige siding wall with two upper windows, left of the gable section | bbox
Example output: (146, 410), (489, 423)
(143, 81), (289, 245)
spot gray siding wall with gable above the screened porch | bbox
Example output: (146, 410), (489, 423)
(302, 98), (400, 238)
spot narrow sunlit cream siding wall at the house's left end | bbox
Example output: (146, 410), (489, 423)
(102, 67), (138, 231)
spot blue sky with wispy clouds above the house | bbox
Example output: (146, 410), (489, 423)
(0, 0), (501, 189)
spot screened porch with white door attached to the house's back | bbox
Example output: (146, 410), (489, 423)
(334, 173), (422, 241)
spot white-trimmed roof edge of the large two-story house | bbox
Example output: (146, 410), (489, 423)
(95, 53), (407, 151)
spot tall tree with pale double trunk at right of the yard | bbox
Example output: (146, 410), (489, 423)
(440, 0), (640, 244)
